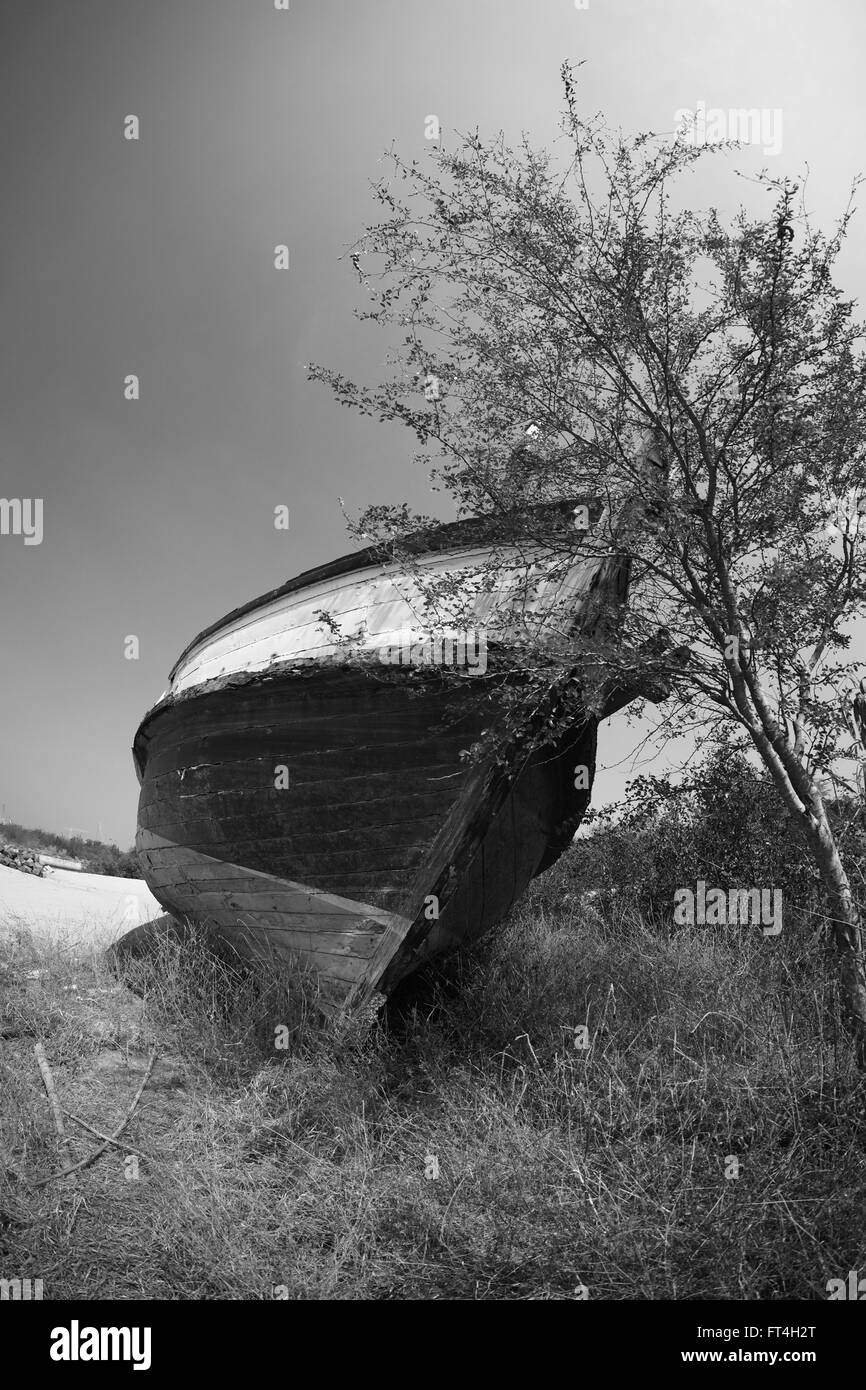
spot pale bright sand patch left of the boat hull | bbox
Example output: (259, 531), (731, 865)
(0, 866), (163, 948)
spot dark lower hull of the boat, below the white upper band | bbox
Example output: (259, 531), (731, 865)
(135, 663), (596, 1006)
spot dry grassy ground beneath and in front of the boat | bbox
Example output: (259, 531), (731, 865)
(0, 856), (866, 1300)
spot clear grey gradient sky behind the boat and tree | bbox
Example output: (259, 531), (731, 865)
(0, 0), (866, 847)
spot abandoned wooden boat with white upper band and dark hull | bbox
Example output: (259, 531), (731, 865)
(133, 503), (644, 1008)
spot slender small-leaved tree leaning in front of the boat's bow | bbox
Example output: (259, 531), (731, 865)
(310, 64), (866, 1062)
